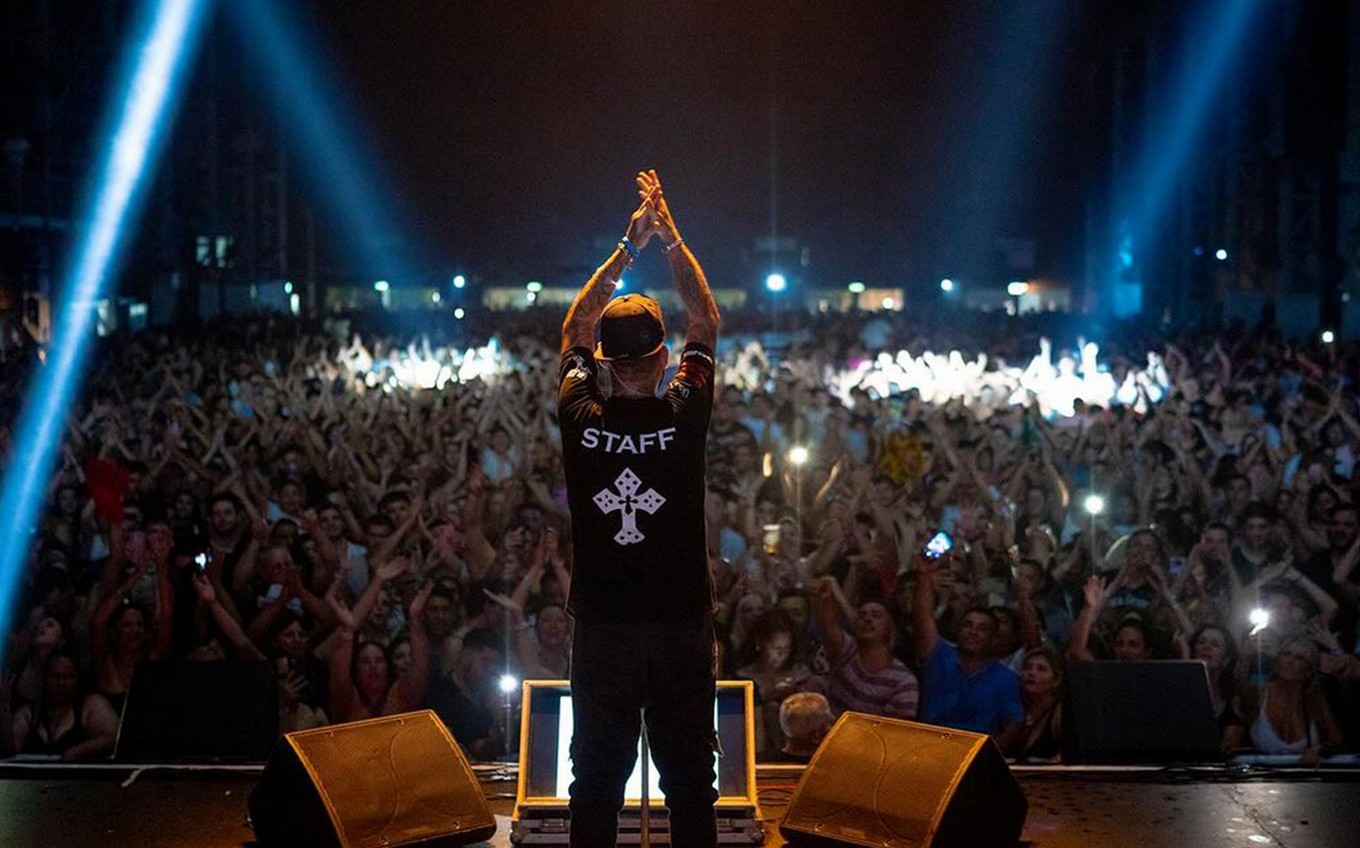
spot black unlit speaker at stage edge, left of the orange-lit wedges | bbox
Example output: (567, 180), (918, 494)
(114, 660), (279, 762)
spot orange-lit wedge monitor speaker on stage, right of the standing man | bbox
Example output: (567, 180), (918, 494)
(779, 712), (1030, 848)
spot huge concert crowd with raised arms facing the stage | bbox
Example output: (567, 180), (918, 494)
(0, 308), (1360, 762)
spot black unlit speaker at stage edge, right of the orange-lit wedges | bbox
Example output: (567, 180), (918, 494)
(1062, 659), (1223, 762)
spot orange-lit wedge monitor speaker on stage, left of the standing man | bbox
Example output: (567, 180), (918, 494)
(249, 709), (496, 848)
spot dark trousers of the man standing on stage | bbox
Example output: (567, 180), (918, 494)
(571, 620), (718, 848)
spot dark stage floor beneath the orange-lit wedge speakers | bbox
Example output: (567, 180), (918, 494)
(0, 764), (1360, 848)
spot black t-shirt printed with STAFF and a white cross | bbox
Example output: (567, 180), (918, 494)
(558, 344), (713, 622)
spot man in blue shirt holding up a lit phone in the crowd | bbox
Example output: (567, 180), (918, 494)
(911, 531), (1024, 739)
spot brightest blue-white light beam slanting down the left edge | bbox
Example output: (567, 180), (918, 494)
(0, 0), (208, 633)
